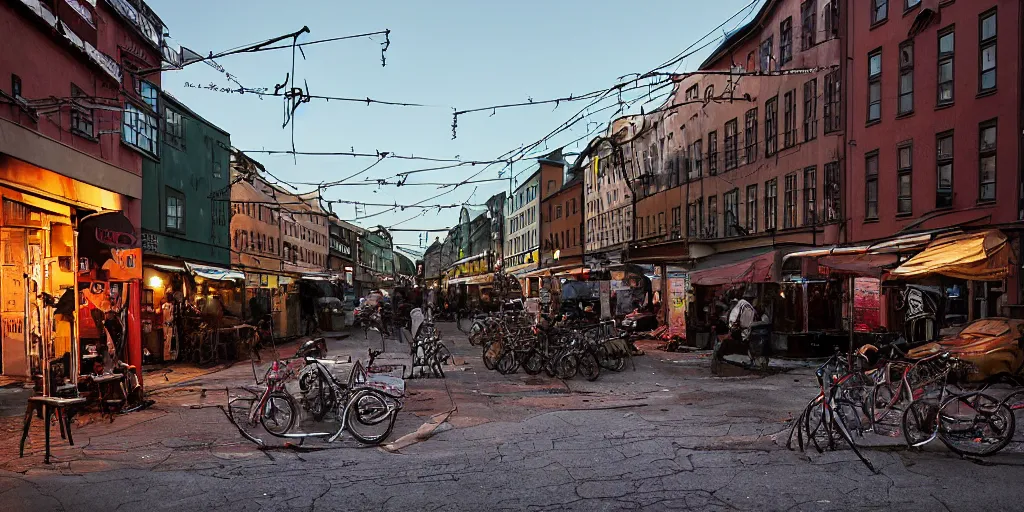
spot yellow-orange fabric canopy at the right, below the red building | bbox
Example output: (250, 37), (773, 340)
(890, 229), (1012, 281)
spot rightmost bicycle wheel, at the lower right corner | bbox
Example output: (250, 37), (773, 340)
(939, 393), (1017, 457)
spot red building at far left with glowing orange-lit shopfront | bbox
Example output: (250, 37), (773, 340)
(0, 0), (165, 385)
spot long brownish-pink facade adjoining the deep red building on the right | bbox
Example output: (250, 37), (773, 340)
(627, 0), (844, 264)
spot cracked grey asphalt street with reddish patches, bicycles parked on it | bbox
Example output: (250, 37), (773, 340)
(0, 329), (1024, 511)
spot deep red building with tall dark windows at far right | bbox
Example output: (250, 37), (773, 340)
(845, 0), (1024, 305)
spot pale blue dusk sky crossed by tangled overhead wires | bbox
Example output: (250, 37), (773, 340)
(150, 0), (754, 252)
